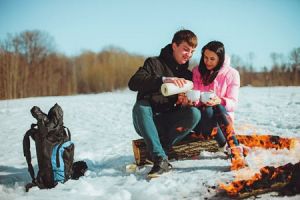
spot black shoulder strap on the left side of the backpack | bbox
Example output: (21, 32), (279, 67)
(23, 124), (36, 183)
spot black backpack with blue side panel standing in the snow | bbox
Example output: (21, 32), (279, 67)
(23, 104), (82, 192)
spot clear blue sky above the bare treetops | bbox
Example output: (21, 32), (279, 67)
(0, 0), (300, 69)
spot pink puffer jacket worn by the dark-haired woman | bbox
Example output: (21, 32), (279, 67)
(192, 56), (240, 120)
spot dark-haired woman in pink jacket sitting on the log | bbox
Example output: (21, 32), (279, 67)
(193, 41), (246, 169)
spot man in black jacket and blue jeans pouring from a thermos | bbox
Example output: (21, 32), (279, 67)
(128, 30), (200, 178)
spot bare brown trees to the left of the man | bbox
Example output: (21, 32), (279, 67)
(0, 31), (145, 99)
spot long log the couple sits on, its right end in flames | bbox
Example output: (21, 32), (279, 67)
(132, 134), (294, 166)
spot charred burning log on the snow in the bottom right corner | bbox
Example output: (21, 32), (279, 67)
(220, 162), (300, 198)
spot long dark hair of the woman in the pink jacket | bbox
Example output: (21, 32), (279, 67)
(198, 41), (225, 85)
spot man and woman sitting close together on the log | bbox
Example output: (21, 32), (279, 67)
(128, 30), (246, 177)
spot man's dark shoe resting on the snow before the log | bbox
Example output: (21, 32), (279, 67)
(148, 157), (172, 178)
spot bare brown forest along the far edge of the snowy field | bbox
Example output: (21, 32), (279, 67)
(0, 30), (300, 99)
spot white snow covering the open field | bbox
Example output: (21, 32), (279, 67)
(0, 87), (300, 200)
